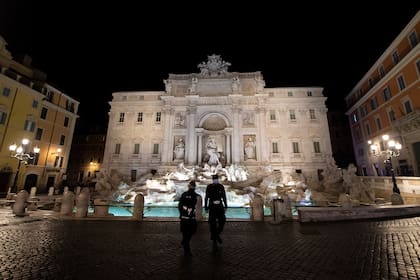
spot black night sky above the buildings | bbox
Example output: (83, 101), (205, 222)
(0, 0), (420, 132)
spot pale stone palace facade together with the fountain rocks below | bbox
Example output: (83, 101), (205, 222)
(98, 55), (358, 217)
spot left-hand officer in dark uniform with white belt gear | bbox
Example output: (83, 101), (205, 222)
(178, 180), (198, 256)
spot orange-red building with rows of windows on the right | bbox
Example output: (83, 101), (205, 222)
(346, 12), (420, 176)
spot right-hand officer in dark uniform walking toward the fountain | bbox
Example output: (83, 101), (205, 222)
(204, 175), (228, 244)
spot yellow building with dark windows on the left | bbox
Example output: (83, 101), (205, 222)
(0, 36), (79, 194)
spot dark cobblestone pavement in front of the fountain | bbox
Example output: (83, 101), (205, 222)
(0, 210), (420, 280)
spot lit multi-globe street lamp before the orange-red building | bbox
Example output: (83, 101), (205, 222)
(368, 134), (402, 194)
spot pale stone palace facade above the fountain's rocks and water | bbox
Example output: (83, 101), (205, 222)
(102, 55), (332, 181)
